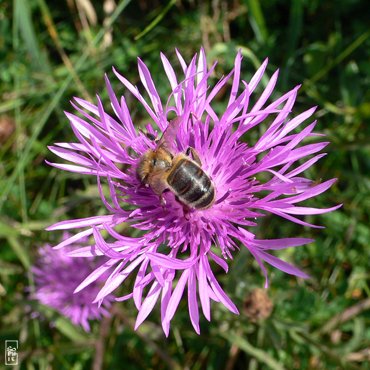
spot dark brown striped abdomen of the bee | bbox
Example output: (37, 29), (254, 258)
(167, 158), (215, 209)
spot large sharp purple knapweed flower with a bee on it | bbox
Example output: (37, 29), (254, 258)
(49, 49), (336, 335)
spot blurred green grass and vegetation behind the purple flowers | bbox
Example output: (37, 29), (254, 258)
(0, 0), (370, 370)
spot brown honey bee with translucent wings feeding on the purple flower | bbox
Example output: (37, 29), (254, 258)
(136, 117), (216, 210)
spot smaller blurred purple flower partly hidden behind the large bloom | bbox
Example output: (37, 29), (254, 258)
(32, 236), (114, 331)
